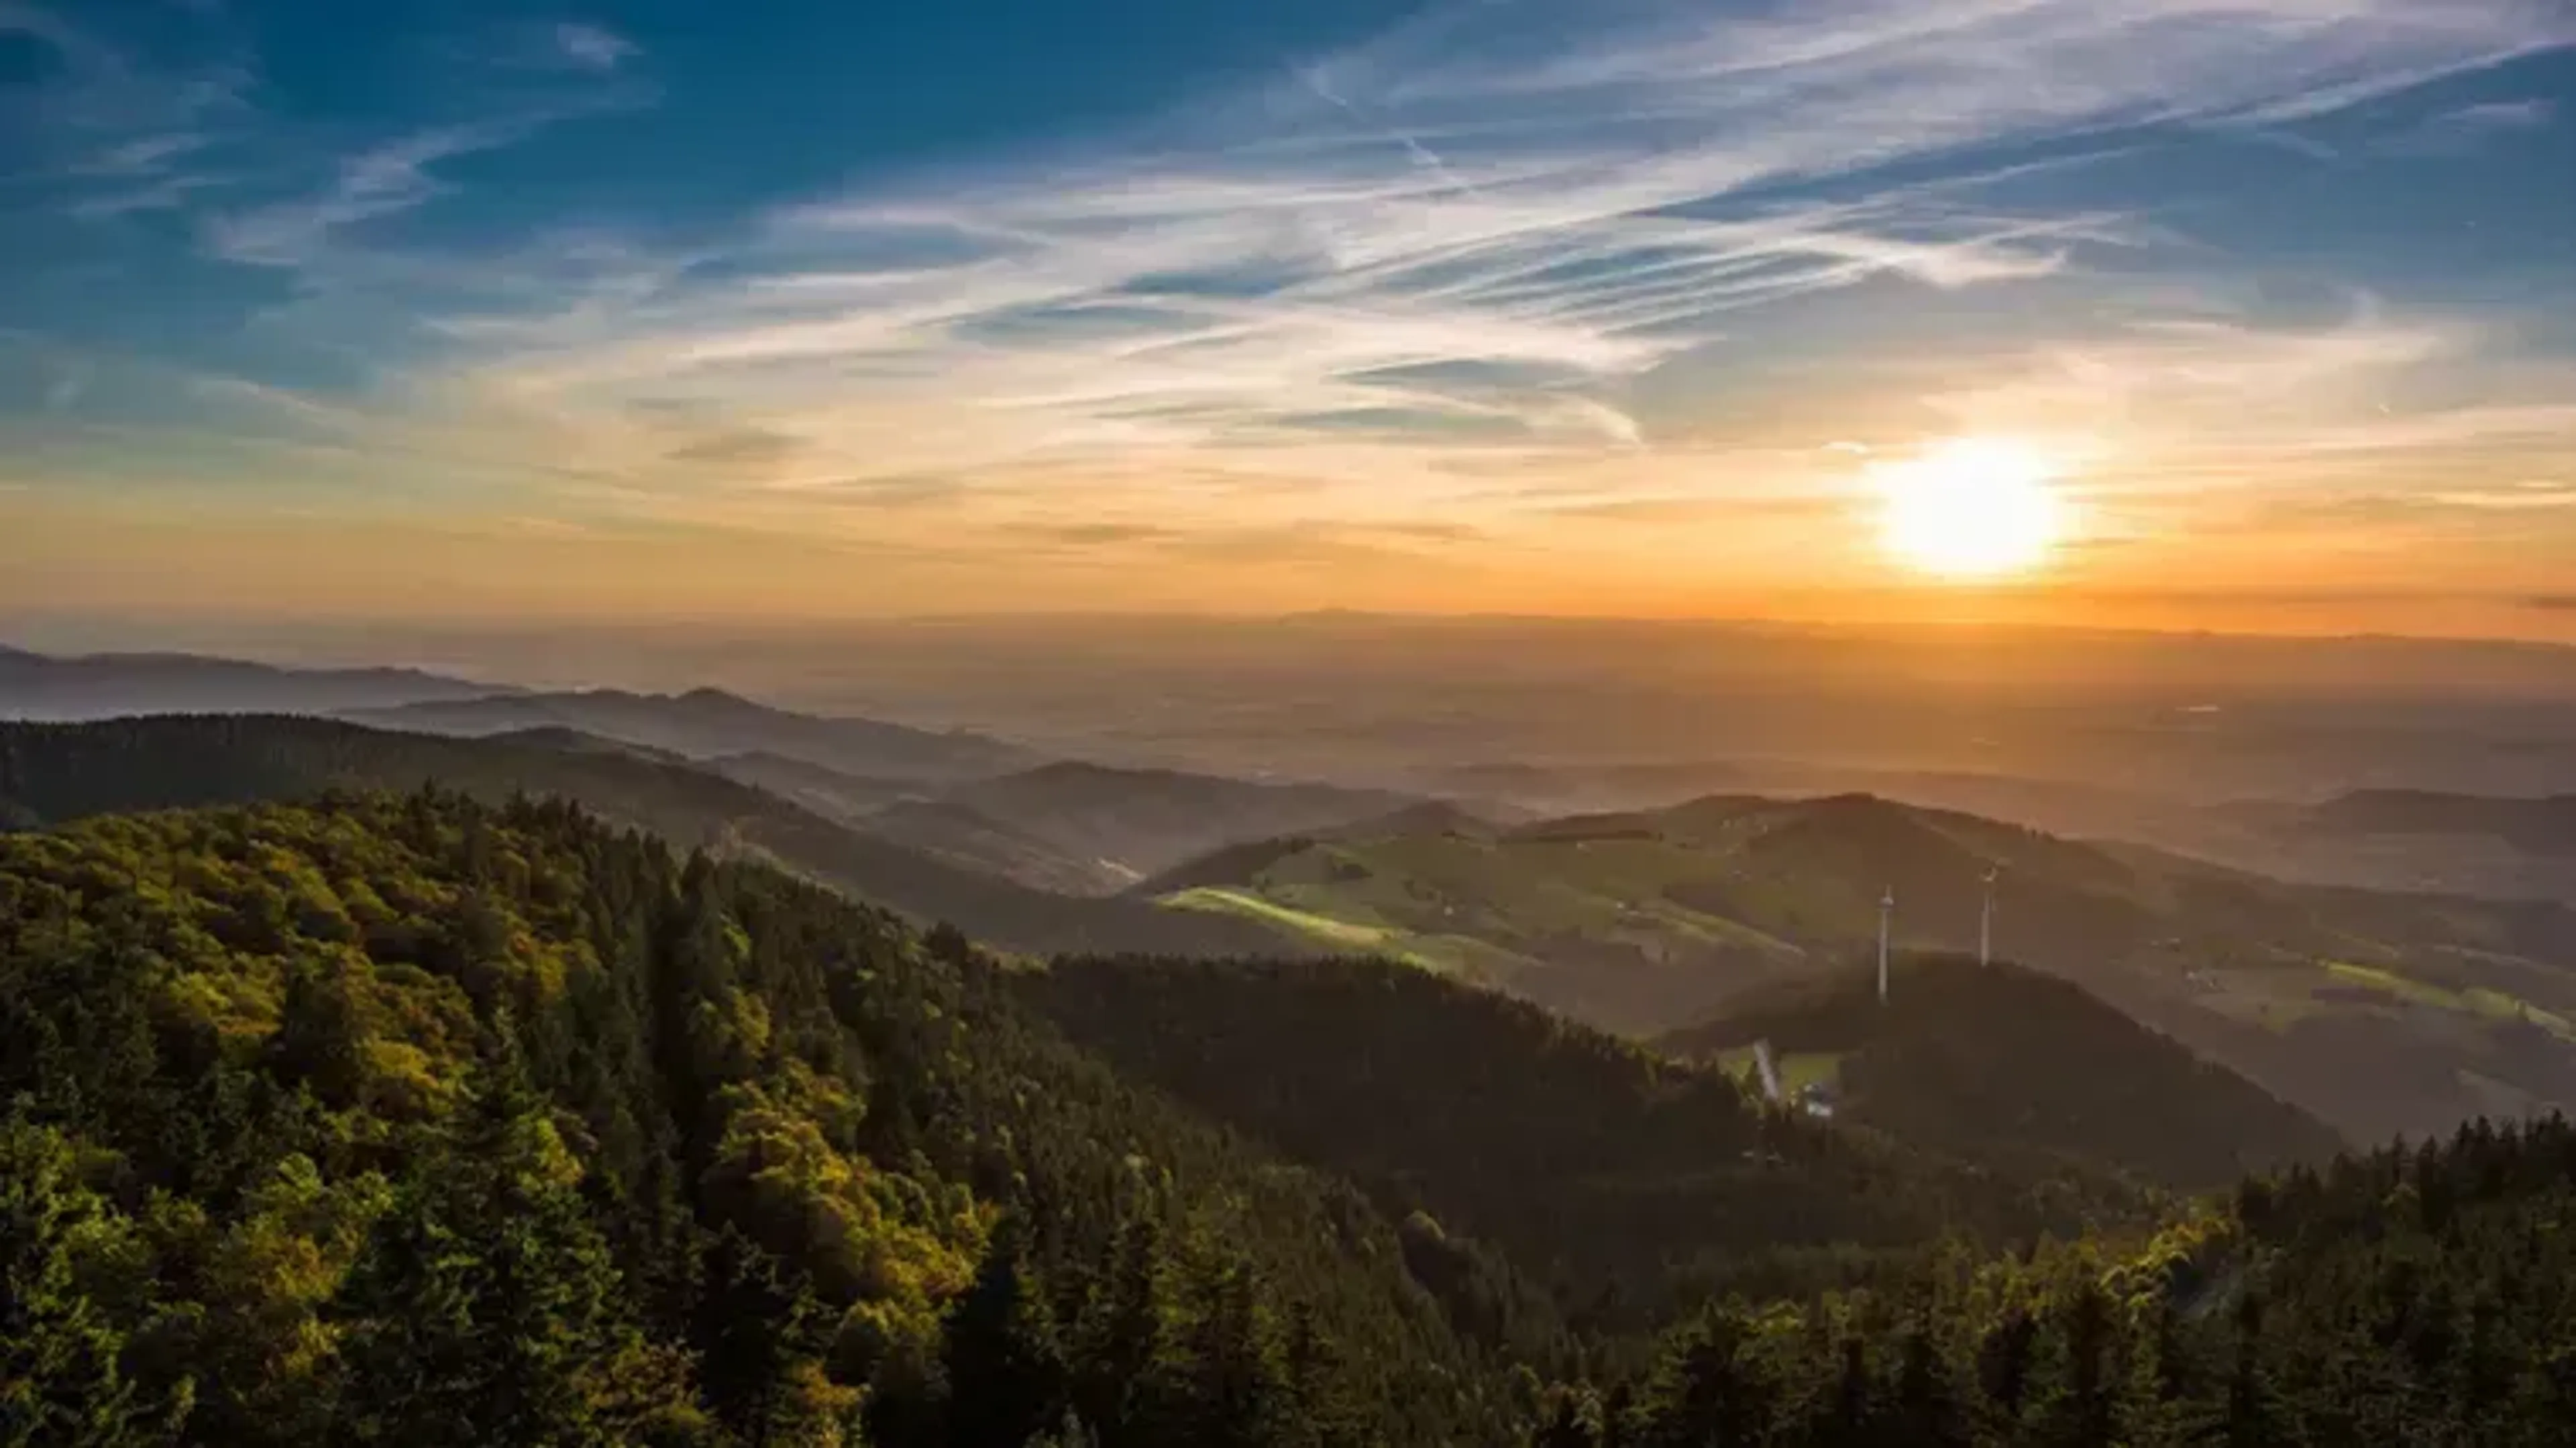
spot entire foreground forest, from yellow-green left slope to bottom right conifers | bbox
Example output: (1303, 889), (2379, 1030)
(0, 788), (2576, 1448)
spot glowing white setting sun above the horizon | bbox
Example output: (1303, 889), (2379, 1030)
(1873, 438), (2066, 580)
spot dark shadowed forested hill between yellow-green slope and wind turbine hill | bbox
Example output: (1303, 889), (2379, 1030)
(1012, 958), (2146, 1327)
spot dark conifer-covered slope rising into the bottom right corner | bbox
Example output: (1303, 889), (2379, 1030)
(1533, 1118), (2576, 1448)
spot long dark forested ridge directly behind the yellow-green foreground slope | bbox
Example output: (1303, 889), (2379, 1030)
(0, 716), (1280, 953)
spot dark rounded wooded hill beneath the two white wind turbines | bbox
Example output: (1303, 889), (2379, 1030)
(1656, 956), (2344, 1190)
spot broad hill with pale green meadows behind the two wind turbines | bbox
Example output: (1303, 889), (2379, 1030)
(1144, 796), (2576, 1139)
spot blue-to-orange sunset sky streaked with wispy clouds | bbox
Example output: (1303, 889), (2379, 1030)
(0, 0), (2576, 641)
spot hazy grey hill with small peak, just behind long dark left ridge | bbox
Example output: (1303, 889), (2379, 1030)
(343, 688), (1038, 780)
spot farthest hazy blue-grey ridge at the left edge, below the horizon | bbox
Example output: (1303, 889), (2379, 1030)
(0, 647), (505, 721)
